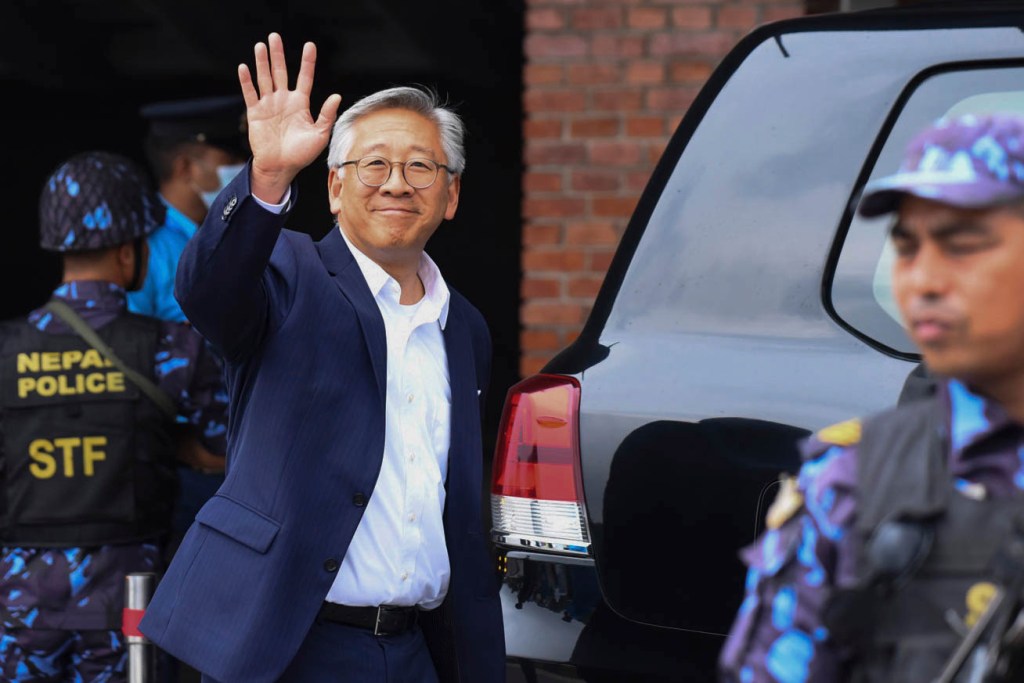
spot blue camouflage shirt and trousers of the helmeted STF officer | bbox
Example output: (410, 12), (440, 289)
(0, 281), (227, 681)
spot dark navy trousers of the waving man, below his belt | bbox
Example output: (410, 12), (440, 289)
(203, 621), (438, 683)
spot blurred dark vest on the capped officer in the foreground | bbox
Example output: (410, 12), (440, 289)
(825, 398), (1024, 683)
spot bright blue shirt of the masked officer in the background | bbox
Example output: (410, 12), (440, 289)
(128, 198), (199, 323)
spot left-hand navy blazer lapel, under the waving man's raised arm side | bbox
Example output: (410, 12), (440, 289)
(316, 225), (387, 401)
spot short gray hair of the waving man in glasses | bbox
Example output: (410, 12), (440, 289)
(327, 86), (466, 174)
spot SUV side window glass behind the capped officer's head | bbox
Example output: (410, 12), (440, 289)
(829, 68), (1024, 355)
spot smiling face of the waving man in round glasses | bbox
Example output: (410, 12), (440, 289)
(328, 109), (460, 274)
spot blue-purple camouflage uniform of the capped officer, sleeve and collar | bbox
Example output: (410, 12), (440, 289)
(720, 380), (1024, 683)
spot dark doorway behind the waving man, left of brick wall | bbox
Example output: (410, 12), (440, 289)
(0, 0), (523, 438)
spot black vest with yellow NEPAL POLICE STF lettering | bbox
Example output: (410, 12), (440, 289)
(0, 313), (177, 547)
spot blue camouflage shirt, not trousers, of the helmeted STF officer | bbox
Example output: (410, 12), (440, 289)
(0, 281), (227, 630)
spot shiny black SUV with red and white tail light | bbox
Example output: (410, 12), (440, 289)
(492, 1), (1024, 683)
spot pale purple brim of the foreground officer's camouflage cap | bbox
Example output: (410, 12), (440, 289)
(857, 172), (1024, 218)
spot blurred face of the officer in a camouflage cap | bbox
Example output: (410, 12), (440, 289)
(892, 197), (1024, 390)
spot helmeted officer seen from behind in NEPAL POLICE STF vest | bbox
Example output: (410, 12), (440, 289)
(0, 152), (226, 681)
